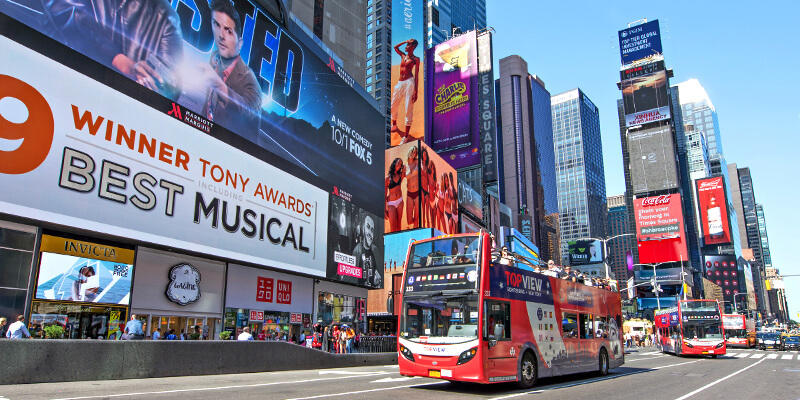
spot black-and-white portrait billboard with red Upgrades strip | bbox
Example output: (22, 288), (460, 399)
(327, 188), (384, 289)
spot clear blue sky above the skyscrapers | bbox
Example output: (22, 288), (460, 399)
(487, 0), (800, 320)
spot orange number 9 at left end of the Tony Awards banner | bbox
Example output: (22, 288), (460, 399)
(0, 75), (54, 174)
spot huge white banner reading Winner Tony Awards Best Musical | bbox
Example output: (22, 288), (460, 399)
(0, 33), (329, 276)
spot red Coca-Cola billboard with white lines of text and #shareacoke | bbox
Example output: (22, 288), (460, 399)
(633, 193), (688, 263)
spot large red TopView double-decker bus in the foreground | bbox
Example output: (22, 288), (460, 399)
(398, 232), (624, 387)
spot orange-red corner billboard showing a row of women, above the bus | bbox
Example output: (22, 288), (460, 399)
(384, 140), (458, 234)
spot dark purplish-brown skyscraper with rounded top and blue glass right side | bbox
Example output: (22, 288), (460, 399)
(495, 55), (560, 261)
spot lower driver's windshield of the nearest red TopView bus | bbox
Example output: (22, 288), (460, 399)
(400, 292), (478, 344)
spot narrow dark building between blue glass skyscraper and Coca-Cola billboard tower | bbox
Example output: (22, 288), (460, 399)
(607, 194), (636, 296)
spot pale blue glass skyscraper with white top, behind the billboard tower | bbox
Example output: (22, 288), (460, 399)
(678, 79), (726, 174)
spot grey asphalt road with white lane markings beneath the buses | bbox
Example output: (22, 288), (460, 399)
(0, 349), (800, 400)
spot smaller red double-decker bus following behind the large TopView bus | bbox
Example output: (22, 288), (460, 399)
(655, 300), (726, 358)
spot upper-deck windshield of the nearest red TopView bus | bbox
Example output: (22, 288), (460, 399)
(409, 236), (480, 269)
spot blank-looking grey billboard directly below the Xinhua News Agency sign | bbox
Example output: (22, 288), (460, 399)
(627, 125), (678, 194)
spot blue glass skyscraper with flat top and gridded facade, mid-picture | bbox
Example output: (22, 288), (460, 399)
(551, 89), (608, 260)
